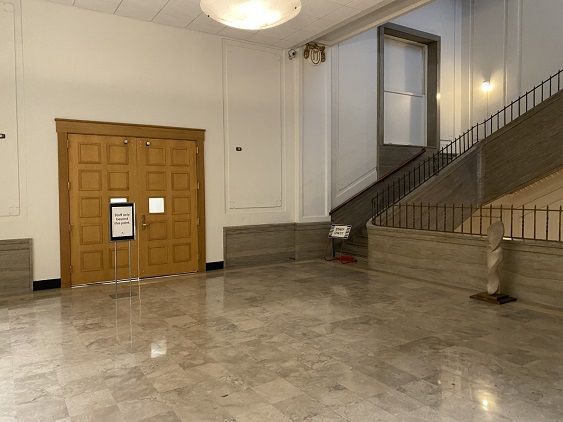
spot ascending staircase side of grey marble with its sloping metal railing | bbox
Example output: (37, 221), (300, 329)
(372, 70), (563, 224)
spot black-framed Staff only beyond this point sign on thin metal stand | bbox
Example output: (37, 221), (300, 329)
(109, 202), (137, 299)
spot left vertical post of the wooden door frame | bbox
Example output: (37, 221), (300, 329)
(57, 131), (71, 287)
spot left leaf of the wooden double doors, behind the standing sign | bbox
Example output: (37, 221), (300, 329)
(68, 135), (137, 285)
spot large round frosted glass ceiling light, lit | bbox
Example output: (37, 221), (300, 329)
(199, 0), (301, 30)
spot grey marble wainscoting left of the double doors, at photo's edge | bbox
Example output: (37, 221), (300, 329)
(0, 239), (33, 296)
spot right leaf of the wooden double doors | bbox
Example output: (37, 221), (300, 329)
(137, 138), (198, 277)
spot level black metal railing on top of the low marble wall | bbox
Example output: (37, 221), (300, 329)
(374, 203), (563, 242)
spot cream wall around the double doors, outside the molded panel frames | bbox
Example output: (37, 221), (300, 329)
(0, 0), (295, 280)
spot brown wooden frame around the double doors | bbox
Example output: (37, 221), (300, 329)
(55, 118), (206, 287)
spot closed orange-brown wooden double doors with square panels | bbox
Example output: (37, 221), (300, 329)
(67, 134), (199, 285)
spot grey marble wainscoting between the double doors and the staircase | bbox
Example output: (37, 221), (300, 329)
(223, 222), (331, 268)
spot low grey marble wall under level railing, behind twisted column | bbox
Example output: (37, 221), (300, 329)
(368, 224), (563, 309)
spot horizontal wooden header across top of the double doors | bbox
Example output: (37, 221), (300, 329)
(55, 119), (205, 141)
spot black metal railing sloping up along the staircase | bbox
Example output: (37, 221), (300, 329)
(372, 69), (563, 224)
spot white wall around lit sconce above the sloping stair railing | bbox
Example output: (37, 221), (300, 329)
(462, 0), (563, 123)
